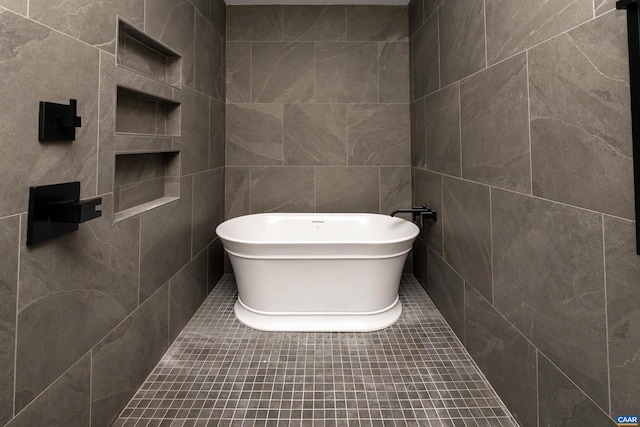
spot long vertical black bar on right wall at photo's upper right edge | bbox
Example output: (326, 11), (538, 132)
(616, 0), (640, 255)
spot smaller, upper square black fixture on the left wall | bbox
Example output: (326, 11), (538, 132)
(38, 99), (82, 142)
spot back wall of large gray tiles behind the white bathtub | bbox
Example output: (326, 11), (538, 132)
(225, 5), (411, 217)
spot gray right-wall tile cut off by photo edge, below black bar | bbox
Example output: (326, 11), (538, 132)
(604, 216), (640, 415)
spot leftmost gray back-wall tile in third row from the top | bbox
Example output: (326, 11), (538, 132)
(225, 104), (282, 166)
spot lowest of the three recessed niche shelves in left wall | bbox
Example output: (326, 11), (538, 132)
(113, 151), (180, 222)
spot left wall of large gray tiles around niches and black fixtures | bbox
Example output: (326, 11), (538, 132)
(0, 0), (225, 427)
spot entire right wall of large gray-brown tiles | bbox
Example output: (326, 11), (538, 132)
(409, 0), (640, 426)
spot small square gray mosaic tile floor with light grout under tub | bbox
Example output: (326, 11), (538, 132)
(114, 275), (518, 427)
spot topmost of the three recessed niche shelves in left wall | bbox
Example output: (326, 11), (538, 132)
(116, 18), (182, 87)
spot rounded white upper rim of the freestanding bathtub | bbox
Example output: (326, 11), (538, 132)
(216, 212), (420, 246)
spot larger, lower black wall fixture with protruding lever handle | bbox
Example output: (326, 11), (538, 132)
(27, 182), (102, 246)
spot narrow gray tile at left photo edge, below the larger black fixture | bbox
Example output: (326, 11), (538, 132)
(0, 216), (20, 424)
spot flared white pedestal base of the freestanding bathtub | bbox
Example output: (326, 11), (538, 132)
(234, 299), (402, 332)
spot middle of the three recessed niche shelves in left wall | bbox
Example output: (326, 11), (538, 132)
(116, 86), (180, 136)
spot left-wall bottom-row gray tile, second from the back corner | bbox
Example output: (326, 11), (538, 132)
(169, 254), (206, 342)
